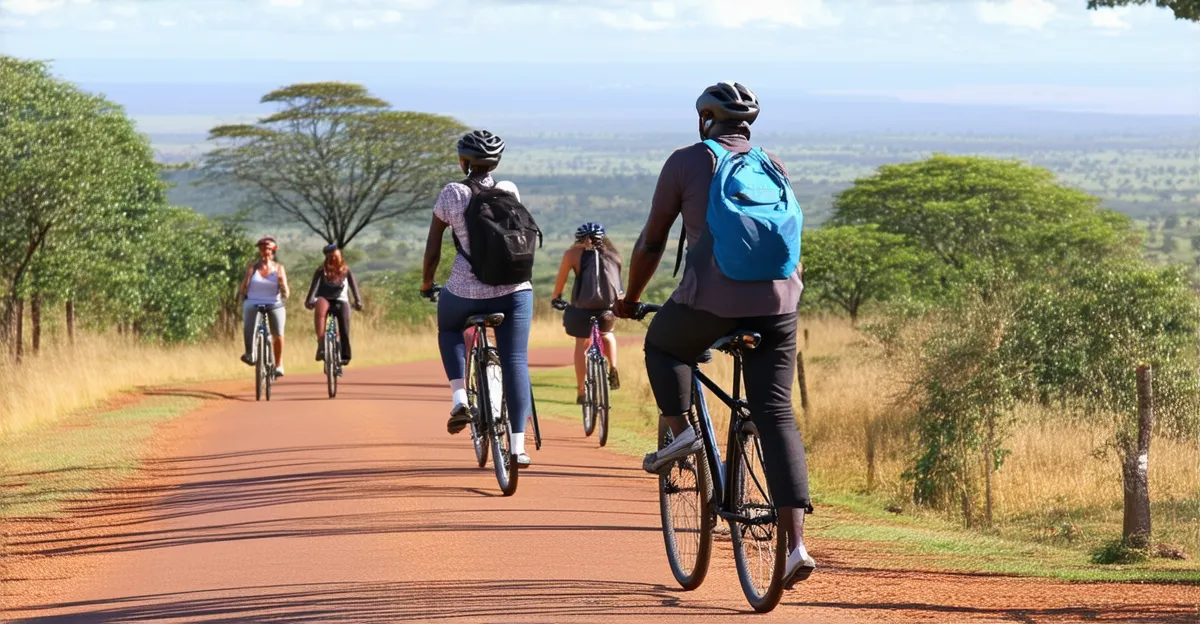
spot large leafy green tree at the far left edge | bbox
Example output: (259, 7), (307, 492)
(0, 56), (164, 344)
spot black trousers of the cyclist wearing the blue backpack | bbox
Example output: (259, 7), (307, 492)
(646, 300), (812, 511)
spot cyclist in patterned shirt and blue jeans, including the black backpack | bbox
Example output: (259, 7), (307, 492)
(421, 130), (541, 467)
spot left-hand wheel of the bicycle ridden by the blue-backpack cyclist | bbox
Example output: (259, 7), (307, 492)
(659, 419), (713, 590)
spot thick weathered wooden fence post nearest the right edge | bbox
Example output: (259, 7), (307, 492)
(1121, 365), (1154, 548)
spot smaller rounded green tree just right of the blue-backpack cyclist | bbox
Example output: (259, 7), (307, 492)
(802, 224), (932, 323)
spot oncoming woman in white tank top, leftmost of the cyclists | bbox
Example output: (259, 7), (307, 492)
(241, 236), (290, 377)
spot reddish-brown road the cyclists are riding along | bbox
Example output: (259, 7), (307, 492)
(0, 352), (1200, 623)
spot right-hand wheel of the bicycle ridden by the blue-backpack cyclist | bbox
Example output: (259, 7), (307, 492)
(728, 421), (787, 613)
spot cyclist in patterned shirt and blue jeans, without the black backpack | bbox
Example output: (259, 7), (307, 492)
(421, 130), (533, 467)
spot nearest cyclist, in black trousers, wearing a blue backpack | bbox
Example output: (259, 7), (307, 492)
(616, 82), (816, 587)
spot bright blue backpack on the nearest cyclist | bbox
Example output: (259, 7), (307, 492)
(676, 139), (804, 282)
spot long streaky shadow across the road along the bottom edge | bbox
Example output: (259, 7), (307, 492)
(14, 578), (739, 624)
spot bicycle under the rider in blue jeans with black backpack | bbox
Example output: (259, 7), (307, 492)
(422, 286), (541, 496)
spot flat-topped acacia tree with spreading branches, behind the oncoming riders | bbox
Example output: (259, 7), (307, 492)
(205, 83), (466, 247)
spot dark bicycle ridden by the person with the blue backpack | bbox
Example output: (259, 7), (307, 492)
(635, 305), (787, 613)
